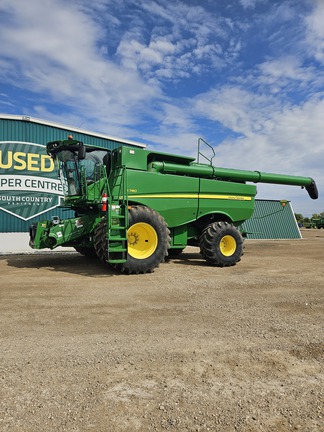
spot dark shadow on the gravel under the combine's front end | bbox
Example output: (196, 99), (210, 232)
(0, 252), (119, 277)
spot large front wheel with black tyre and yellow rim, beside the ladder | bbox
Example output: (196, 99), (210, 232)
(114, 206), (170, 274)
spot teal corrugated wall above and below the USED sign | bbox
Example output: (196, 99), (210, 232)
(0, 115), (144, 233)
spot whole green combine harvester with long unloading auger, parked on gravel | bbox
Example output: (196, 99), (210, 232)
(30, 139), (318, 274)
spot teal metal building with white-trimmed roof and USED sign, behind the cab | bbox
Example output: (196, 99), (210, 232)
(0, 114), (145, 252)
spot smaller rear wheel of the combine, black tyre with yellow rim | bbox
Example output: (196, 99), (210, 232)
(199, 222), (243, 267)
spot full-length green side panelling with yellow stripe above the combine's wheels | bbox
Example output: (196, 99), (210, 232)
(123, 170), (256, 228)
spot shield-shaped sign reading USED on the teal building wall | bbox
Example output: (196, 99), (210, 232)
(0, 141), (63, 220)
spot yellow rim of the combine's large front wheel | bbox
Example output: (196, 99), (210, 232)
(127, 222), (158, 259)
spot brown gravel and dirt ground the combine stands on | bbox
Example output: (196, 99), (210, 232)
(0, 230), (324, 432)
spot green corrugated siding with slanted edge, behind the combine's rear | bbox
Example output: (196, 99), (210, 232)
(240, 200), (301, 239)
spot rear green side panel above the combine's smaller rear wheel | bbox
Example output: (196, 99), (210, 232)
(198, 179), (256, 224)
